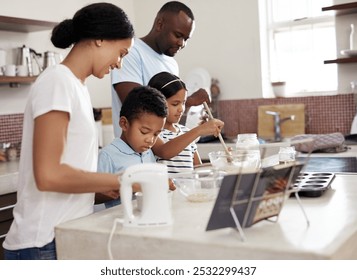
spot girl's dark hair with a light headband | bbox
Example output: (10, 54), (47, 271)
(149, 72), (187, 99)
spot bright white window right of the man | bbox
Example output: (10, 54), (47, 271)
(266, 0), (337, 95)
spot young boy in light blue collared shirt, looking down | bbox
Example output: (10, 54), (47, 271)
(95, 86), (169, 211)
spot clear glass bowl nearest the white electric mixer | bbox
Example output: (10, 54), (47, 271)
(170, 169), (225, 202)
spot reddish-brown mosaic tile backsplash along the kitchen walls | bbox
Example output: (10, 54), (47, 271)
(0, 94), (356, 152)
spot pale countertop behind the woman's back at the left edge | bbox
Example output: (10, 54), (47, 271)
(0, 160), (19, 195)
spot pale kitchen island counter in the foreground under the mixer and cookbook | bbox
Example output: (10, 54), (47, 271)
(56, 174), (357, 259)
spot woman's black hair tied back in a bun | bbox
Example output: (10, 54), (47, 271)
(51, 3), (134, 49)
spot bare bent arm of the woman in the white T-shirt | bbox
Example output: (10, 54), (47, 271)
(33, 111), (119, 193)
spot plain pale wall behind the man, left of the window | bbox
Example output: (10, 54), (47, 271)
(133, 0), (262, 100)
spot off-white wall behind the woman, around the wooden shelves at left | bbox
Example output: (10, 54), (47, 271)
(0, 0), (134, 115)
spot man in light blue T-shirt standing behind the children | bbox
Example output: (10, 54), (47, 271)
(111, 1), (210, 137)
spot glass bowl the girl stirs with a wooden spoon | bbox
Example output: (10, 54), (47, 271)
(208, 150), (261, 173)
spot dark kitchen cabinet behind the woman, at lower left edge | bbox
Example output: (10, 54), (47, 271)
(0, 192), (16, 260)
